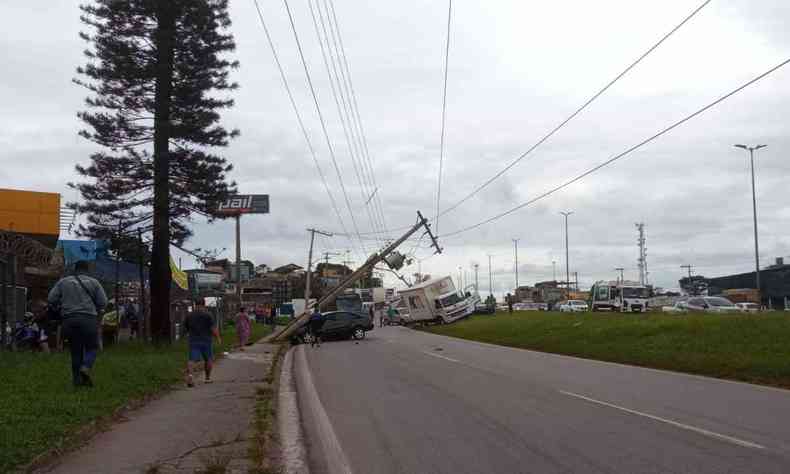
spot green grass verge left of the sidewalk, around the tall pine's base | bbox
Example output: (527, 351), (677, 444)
(0, 324), (269, 472)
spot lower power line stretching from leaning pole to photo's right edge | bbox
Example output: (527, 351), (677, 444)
(441, 59), (790, 238)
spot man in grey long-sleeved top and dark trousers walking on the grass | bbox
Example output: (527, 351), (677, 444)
(47, 260), (107, 387)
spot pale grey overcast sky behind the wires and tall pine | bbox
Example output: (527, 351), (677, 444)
(0, 0), (790, 293)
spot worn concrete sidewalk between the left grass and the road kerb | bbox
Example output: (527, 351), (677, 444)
(38, 343), (277, 474)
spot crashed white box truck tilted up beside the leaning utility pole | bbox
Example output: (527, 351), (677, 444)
(398, 276), (480, 323)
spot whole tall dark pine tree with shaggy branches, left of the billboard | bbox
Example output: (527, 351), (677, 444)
(72, 0), (239, 341)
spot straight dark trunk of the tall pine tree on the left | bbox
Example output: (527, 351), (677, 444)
(150, 2), (175, 343)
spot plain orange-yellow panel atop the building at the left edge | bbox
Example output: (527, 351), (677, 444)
(0, 188), (60, 235)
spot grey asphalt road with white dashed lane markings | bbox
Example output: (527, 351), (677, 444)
(295, 327), (790, 474)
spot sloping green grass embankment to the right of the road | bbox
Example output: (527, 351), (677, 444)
(426, 311), (790, 388)
